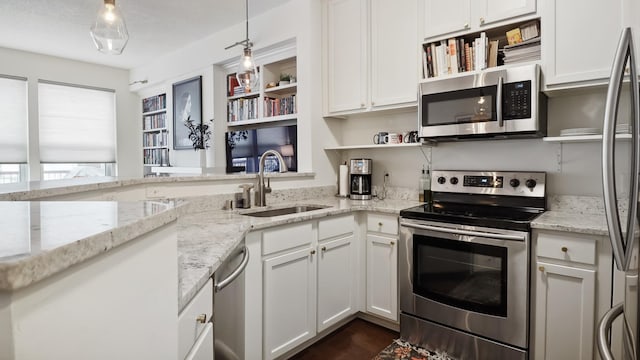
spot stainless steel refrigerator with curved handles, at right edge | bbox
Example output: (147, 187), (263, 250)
(597, 28), (640, 360)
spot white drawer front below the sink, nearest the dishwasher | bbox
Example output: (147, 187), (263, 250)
(262, 222), (313, 255)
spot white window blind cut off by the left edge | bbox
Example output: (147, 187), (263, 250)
(0, 76), (29, 164)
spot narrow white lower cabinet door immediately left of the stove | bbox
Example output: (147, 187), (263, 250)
(367, 234), (398, 321)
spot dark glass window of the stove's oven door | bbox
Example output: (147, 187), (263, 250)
(413, 235), (507, 317)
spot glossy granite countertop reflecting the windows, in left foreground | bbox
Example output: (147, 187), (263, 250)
(0, 200), (178, 291)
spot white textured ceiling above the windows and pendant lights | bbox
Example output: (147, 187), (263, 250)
(0, 0), (288, 70)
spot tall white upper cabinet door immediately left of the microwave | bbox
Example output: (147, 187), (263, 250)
(371, 0), (419, 108)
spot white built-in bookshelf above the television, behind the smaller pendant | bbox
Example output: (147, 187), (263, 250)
(226, 57), (298, 127)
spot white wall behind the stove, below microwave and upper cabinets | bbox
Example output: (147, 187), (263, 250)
(338, 89), (606, 196)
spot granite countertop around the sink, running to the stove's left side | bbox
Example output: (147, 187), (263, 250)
(178, 197), (420, 309)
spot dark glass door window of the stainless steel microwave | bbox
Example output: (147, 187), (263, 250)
(422, 85), (497, 126)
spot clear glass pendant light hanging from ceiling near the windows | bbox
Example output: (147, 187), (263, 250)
(90, 0), (129, 55)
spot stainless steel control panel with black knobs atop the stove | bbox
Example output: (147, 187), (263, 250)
(431, 170), (546, 197)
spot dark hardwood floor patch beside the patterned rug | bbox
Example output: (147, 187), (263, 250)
(291, 319), (400, 360)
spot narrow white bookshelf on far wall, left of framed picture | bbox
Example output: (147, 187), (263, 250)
(142, 94), (169, 176)
